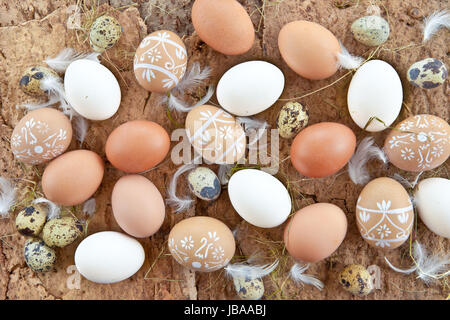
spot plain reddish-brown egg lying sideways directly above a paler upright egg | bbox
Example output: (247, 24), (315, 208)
(105, 120), (170, 173)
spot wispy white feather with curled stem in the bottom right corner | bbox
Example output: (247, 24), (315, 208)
(384, 241), (450, 284)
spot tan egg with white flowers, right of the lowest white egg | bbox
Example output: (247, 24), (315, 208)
(169, 216), (236, 272)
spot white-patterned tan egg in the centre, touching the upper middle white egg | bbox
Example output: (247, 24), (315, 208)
(186, 105), (247, 164)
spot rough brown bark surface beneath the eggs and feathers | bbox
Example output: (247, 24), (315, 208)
(0, 0), (450, 299)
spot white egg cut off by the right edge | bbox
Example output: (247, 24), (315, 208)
(414, 178), (450, 239)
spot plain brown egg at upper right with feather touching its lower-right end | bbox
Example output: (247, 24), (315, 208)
(278, 20), (342, 80)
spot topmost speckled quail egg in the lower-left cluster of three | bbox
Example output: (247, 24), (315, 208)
(16, 204), (48, 237)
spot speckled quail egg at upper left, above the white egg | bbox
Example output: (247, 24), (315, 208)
(89, 16), (123, 52)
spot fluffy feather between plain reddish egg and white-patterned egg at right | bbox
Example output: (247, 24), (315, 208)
(348, 137), (388, 184)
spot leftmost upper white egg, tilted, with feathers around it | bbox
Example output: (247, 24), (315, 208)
(64, 59), (121, 120)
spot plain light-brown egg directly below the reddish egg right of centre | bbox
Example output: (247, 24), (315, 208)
(284, 203), (347, 262)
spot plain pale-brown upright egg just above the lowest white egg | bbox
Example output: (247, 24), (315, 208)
(111, 174), (166, 238)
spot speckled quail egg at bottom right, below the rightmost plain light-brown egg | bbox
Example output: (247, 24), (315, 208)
(339, 264), (373, 296)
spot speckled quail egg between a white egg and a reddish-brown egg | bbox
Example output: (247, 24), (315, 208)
(277, 102), (309, 139)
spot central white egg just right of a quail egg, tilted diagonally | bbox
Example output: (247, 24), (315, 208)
(228, 169), (291, 228)
